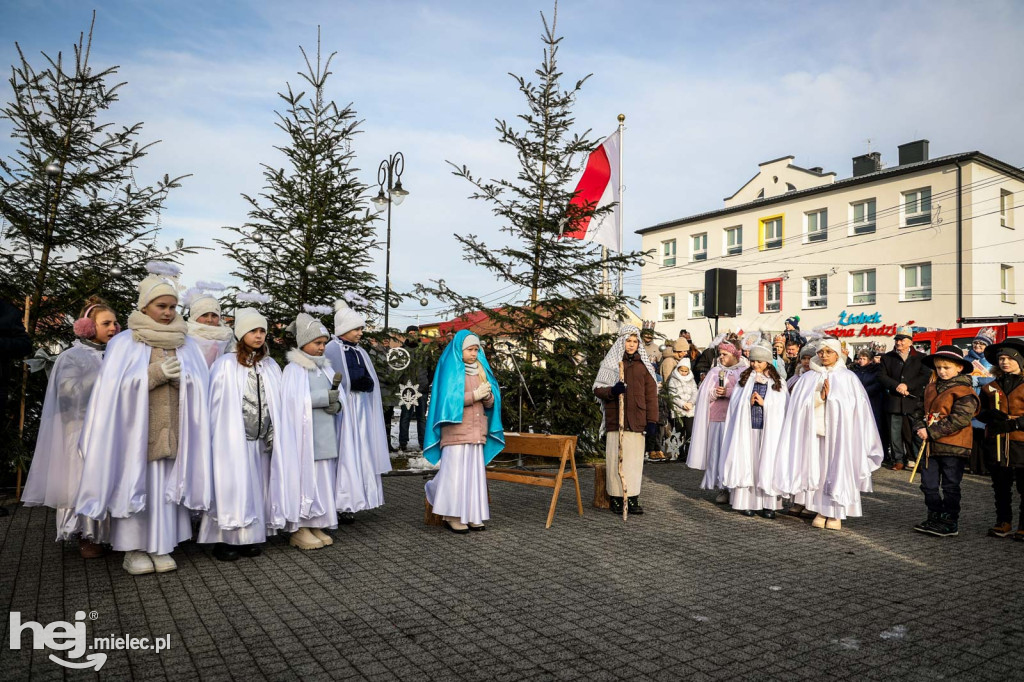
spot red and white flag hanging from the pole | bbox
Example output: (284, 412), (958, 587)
(562, 130), (623, 252)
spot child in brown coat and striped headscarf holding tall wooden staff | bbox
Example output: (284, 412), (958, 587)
(594, 325), (657, 516)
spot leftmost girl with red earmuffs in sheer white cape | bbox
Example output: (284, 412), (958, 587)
(22, 296), (121, 559)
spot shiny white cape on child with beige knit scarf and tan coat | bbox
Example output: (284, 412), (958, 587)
(75, 330), (213, 520)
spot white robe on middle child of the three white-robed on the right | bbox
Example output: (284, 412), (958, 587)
(722, 372), (787, 509)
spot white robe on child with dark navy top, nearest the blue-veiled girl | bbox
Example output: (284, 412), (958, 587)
(324, 339), (391, 512)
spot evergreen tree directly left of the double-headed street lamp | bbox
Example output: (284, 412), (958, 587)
(218, 31), (383, 352)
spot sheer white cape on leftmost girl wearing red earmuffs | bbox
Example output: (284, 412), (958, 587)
(22, 340), (110, 543)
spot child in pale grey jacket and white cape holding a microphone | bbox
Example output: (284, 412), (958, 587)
(278, 306), (342, 550)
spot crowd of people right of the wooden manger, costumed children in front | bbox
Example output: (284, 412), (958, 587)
(594, 317), (1024, 541)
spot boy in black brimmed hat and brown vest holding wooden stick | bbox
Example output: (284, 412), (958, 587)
(910, 346), (980, 538)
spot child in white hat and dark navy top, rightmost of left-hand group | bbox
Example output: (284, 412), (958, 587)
(325, 299), (391, 523)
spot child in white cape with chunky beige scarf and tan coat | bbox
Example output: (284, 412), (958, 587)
(75, 263), (212, 574)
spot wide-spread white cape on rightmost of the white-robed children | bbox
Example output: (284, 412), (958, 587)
(774, 361), (882, 519)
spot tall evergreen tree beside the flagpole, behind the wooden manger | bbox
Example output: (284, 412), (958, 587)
(425, 5), (641, 452)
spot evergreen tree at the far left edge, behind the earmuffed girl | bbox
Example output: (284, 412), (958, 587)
(0, 14), (194, 483)
